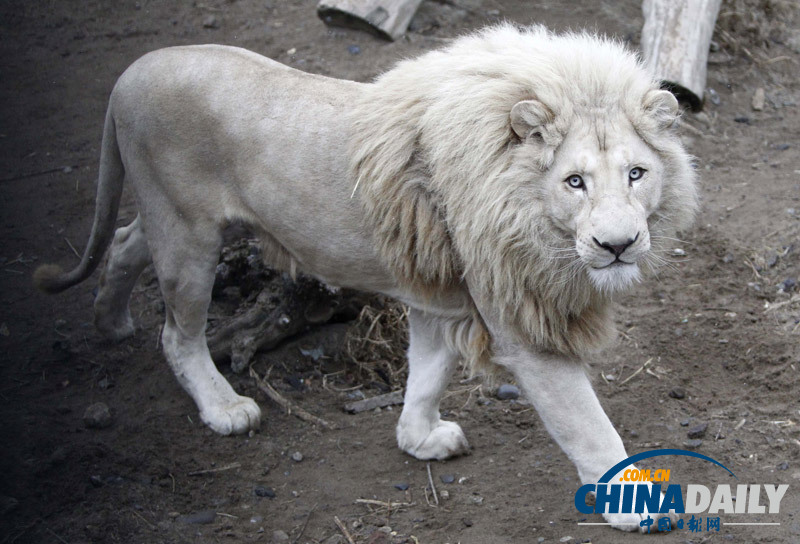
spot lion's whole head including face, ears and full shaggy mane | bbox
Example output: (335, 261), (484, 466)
(353, 25), (697, 354)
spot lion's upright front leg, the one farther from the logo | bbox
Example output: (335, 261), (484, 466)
(397, 309), (469, 459)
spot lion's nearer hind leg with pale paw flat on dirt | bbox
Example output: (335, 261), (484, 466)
(145, 211), (261, 435)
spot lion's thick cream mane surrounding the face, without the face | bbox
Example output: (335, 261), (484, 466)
(351, 25), (697, 366)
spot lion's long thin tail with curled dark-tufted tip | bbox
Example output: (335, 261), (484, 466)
(33, 105), (125, 293)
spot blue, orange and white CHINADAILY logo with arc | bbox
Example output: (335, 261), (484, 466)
(575, 449), (789, 533)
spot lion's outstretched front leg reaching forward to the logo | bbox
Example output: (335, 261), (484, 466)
(497, 346), (676, 532)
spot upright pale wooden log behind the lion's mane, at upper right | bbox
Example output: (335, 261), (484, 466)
(642, 0), (721, 111)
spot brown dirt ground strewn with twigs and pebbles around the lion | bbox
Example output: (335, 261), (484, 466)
(0, 0), (800, 544)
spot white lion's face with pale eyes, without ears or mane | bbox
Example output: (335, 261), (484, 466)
(543, 116), (664, 292)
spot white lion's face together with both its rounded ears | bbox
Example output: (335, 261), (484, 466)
(511, 91), (678, 293)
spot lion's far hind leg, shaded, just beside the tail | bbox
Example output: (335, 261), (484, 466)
(94, 215), (152, 340)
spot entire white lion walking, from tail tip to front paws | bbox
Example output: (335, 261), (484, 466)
(35, 25), (697, 530)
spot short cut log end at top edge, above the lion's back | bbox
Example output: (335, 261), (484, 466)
(317, 0), (422, 41)
